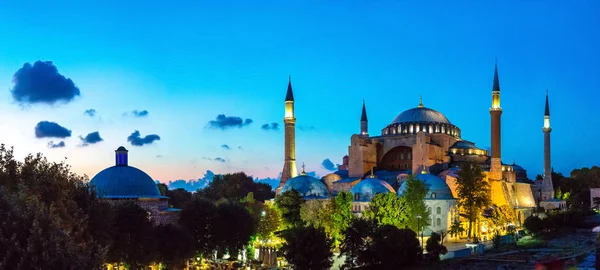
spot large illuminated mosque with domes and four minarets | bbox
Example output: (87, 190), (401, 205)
(276, 65), (564, 239)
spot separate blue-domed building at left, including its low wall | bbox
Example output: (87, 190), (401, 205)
(90, 146), (179, 225)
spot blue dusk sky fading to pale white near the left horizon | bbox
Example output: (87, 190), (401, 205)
(0, 0), (600, 189)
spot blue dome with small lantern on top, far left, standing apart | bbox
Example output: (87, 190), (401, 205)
(90, 146), (166, 199)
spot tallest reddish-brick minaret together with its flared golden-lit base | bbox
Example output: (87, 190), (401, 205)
(488, 64), (508, 206)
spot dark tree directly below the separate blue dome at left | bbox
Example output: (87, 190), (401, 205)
(108, 201), (156, 269)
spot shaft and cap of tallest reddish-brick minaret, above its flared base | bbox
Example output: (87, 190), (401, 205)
(490, 64), (502, 180)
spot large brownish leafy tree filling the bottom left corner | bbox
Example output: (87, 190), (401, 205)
(0, 145), (105, 269)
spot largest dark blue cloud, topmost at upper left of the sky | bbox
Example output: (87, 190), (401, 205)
(11, 61), (81, 105)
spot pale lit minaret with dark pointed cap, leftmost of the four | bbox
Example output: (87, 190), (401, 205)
(279, 76), (298, 189)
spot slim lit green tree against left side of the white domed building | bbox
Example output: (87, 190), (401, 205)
(402, 175), (431, 232)
